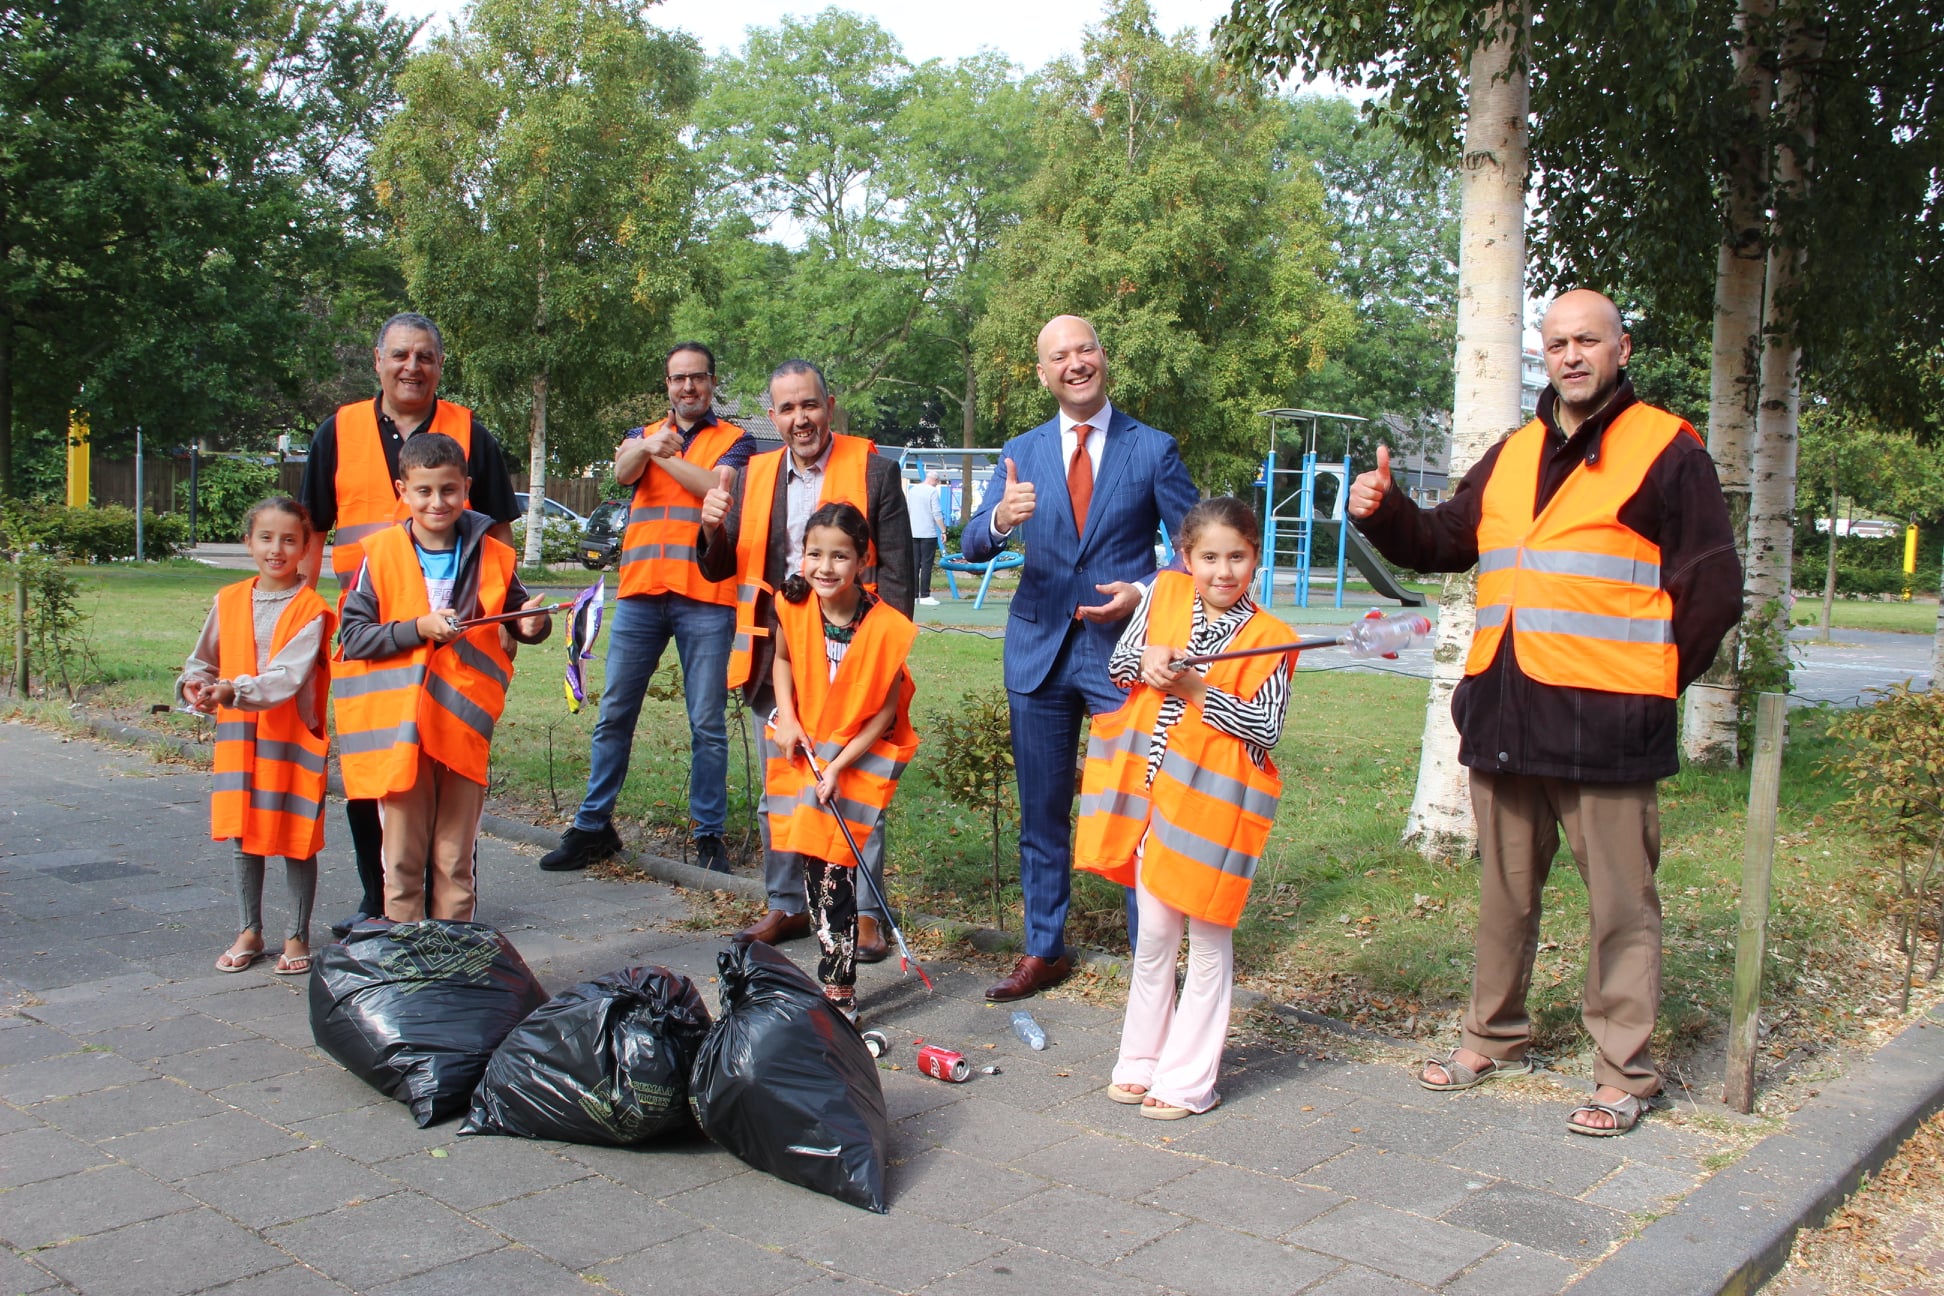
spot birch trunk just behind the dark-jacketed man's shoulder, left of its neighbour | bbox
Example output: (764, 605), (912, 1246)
(1682, 0), (1775, 766)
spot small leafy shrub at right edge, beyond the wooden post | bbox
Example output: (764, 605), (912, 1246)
(1823, 684), (1944, 1012)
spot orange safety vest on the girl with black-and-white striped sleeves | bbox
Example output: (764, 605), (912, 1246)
(1073, 571), (1297, 927)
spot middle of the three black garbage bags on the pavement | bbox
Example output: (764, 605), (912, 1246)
(459, 968), (710, 1146)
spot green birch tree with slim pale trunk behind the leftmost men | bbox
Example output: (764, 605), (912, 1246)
(375, 0), (700, 505)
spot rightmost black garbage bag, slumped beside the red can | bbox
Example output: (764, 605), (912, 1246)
(688, 940), (890, 1214)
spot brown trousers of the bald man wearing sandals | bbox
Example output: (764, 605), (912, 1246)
(1464, 769), (1660, 1098)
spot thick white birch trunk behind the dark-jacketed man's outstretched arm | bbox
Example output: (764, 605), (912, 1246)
(1404, 2), (1528, 859)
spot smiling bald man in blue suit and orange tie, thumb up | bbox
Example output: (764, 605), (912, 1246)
(964, 315), (1198, 1003)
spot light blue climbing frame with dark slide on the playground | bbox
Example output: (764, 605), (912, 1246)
(1256, 410), (1425, 608)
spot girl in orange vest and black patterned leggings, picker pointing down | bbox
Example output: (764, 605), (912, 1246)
(766, 503), (918, 1022)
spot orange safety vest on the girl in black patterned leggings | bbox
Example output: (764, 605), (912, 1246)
(764, 595), (918, 865)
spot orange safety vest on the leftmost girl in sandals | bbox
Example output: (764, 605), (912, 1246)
(210, 577), (338, 859)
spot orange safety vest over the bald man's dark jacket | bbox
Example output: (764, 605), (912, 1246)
(1464, 404), (1701, 698)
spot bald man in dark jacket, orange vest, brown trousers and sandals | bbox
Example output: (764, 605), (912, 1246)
(1349, 290), (1742, 1137)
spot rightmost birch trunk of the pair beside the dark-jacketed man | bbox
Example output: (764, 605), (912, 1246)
(1742, 16), (1822, 688)
